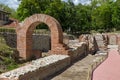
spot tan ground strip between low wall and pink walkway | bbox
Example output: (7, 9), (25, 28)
(45, 54), (105, 80)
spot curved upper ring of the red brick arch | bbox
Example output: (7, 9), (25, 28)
(23, 14), (63, 43)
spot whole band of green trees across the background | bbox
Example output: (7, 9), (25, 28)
(17, 0), (120, 34)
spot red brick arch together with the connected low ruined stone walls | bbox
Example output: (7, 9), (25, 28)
(0, 14), (119, 80)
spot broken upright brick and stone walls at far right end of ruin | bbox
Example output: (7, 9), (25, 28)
(79, 33), (120, 53)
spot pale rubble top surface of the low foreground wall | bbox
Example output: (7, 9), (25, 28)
(0, 55), (70, 80)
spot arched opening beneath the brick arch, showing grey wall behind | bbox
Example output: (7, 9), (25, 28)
(32, 23), (51, 57)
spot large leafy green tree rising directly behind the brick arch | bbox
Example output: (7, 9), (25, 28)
(17, 0), (75, 31)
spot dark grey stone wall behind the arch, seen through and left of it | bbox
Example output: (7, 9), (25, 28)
(0, 33), (51, 51)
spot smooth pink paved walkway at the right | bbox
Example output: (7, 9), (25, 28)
(92, 48), (120, 80)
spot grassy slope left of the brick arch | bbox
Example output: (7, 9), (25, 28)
(0, 37), (18, 73)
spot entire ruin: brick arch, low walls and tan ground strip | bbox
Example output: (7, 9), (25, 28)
(0, 14), (120, 80)
